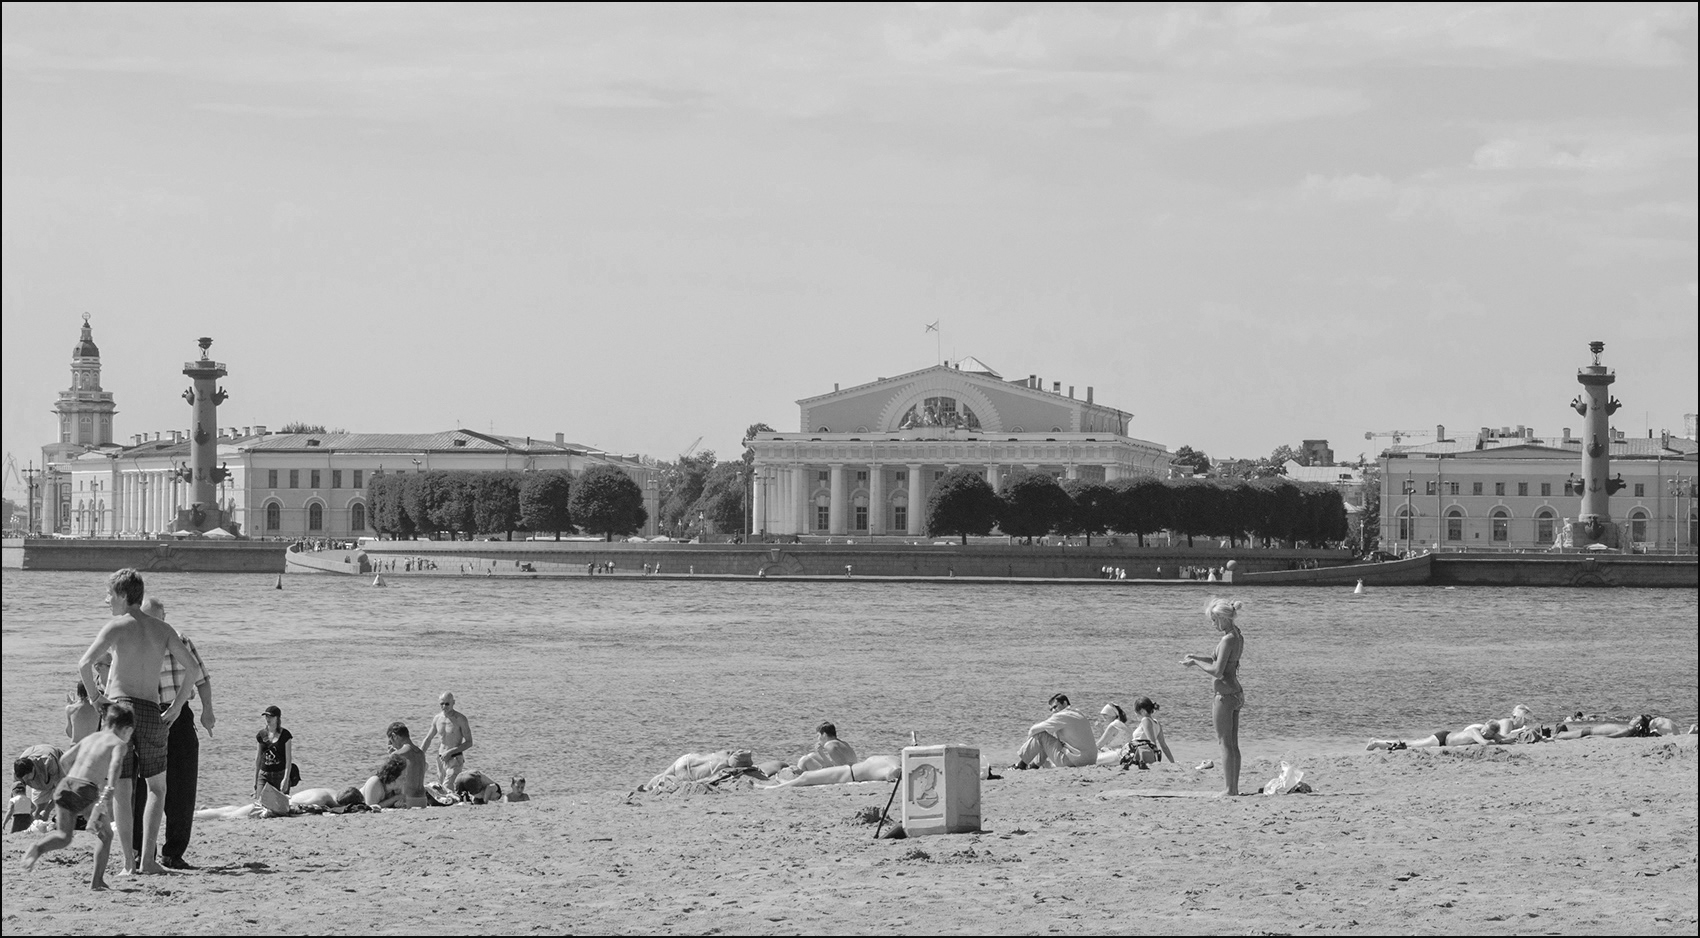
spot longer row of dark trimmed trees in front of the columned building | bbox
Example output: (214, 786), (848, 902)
(927, 467), (1350, 547)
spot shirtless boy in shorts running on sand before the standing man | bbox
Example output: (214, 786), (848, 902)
(24, 702), (136, 889)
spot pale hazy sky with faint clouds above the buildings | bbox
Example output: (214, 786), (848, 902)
(0, 3), (1700, 489)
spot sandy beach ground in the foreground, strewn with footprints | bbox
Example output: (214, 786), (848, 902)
(0, 736), (1697, 935)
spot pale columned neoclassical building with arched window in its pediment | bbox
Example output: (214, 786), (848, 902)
(746, 359), (1170, 537)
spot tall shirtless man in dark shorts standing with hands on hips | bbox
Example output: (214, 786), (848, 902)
(78, 568), (201, 873)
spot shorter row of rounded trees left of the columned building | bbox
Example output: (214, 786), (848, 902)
(366, 466), (649, 540)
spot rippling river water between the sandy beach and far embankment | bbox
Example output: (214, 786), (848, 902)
(0, 569), (1700, 804)
